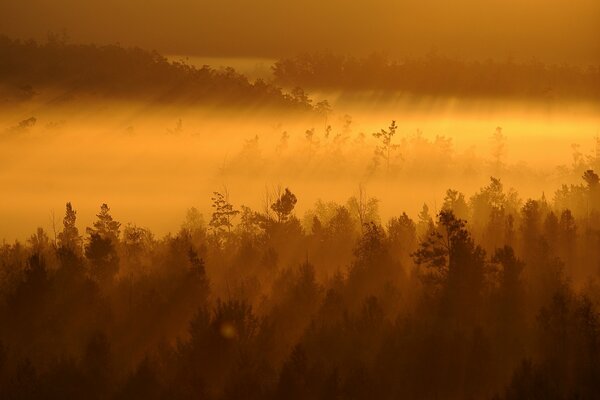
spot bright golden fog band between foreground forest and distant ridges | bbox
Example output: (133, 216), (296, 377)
(0, 93), (600, 241)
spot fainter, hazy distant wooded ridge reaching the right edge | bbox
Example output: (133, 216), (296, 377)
(273, 53), (600, 100)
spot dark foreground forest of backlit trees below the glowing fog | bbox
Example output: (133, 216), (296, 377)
(0, 169), (600, 400)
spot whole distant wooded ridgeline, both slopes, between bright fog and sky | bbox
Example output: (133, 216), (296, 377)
(0, 34), (600, 110)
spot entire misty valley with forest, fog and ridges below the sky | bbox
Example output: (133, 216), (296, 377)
(0, 34), (600, 400)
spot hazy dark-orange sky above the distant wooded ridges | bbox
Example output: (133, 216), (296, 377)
(0, 0), (600, 64)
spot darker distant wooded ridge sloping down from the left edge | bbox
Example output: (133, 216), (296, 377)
(0, 36), (311, 109)
